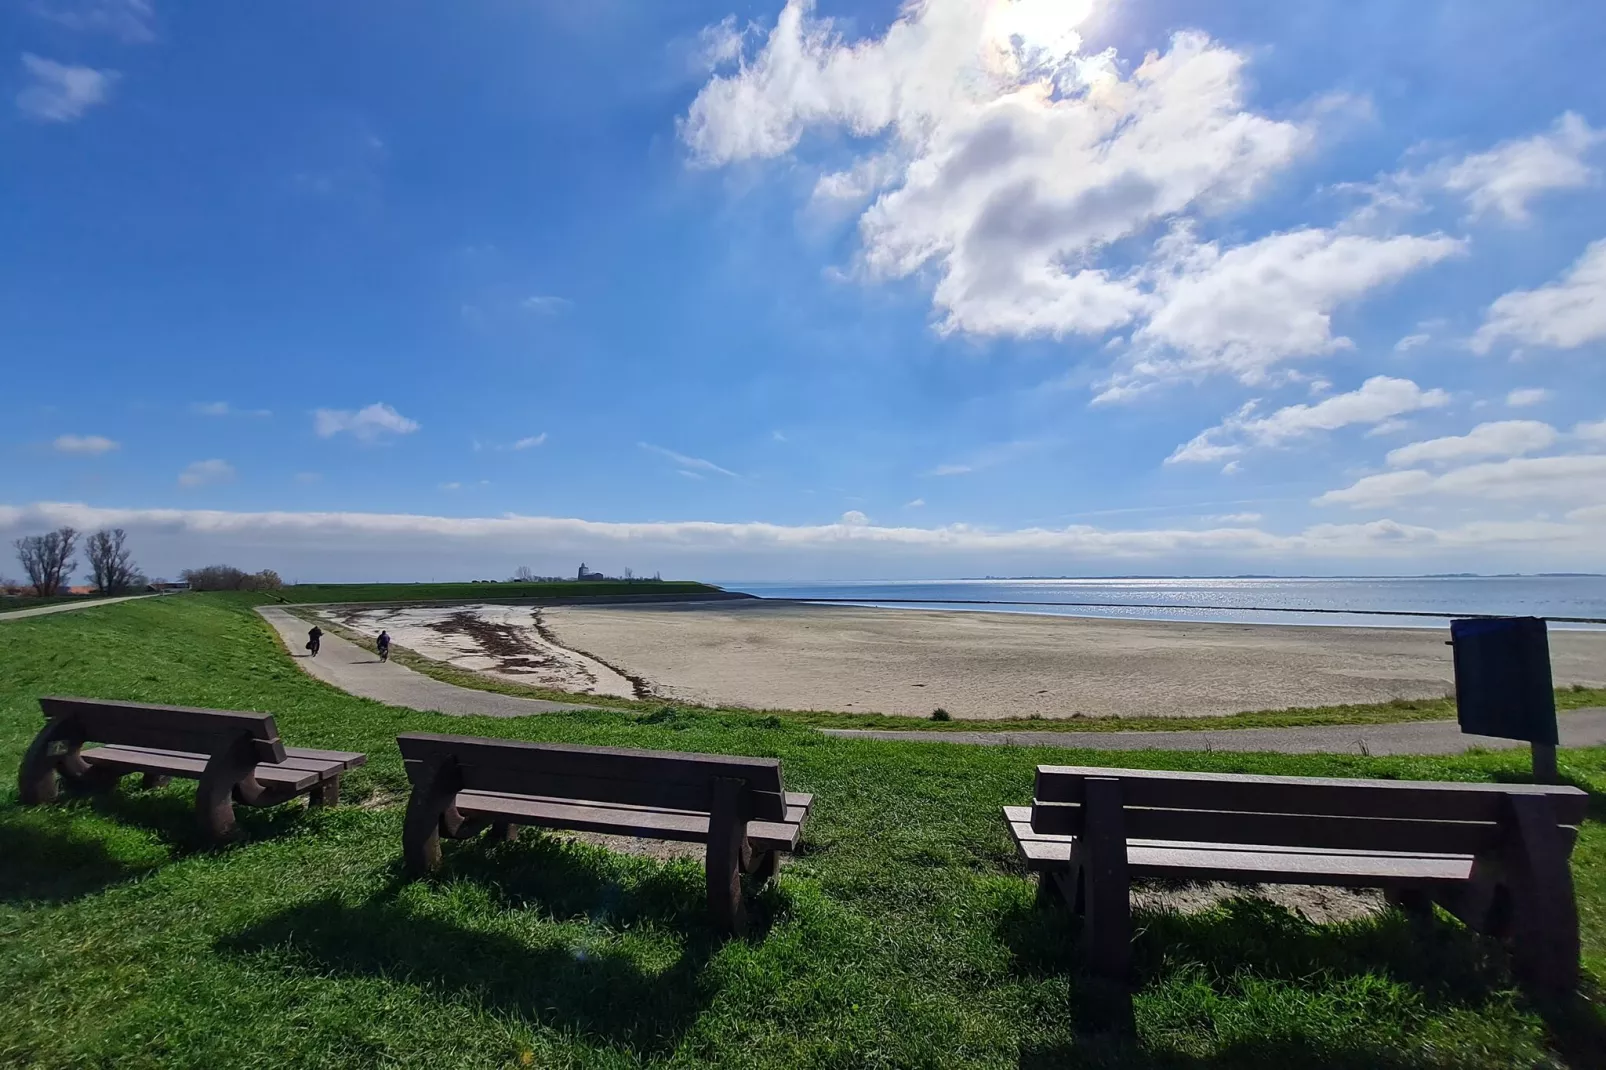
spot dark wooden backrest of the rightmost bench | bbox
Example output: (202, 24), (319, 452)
(1031, 765), (1588, 855)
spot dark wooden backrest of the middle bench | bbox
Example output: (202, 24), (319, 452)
(397, 733), (787, 821)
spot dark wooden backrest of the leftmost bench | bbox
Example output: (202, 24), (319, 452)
(39, 697), (284, 763)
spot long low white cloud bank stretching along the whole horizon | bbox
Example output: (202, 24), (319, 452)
(0, 498), (1606, 580)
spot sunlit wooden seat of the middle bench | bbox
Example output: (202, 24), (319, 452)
(456, 790), (813, 852)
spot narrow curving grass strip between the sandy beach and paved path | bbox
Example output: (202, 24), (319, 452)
(297, 609), (1606, 733)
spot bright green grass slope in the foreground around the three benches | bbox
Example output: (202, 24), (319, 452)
(0, 596), (1606, 1070)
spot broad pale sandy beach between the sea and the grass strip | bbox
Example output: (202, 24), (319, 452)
(536, 601), (1606, 720)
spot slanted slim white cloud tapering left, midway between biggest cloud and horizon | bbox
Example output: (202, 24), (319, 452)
(1166, 376), (1450, 464)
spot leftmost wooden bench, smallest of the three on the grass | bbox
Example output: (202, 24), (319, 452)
(18, 699), (368, 840)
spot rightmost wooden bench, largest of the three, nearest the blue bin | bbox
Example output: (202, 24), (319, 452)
(1004, 765), (1588, 990)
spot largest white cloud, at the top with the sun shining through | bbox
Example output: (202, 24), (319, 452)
(681, 0), (1310, 336)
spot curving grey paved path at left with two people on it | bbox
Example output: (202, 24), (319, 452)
(257, 606), (594, 717)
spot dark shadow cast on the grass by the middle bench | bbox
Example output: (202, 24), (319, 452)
(218, 831), (781, 1056)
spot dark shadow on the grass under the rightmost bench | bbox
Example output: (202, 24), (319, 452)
(999, 896), (1580, 1070)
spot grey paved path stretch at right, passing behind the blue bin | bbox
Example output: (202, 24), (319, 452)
(824, 709), (1606, 755)
